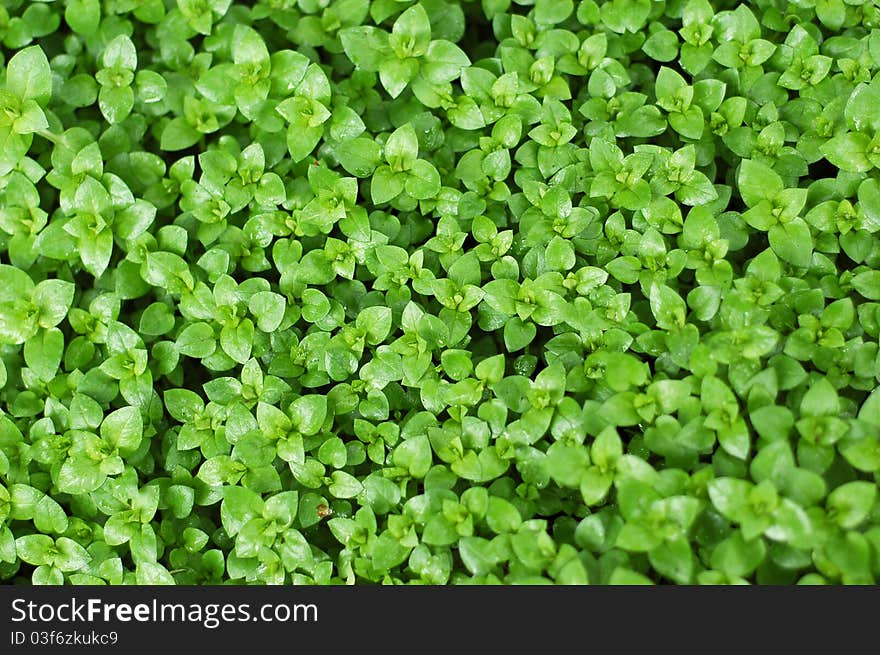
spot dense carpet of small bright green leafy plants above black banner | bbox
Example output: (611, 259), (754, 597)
(0, 0), (880, 584)
